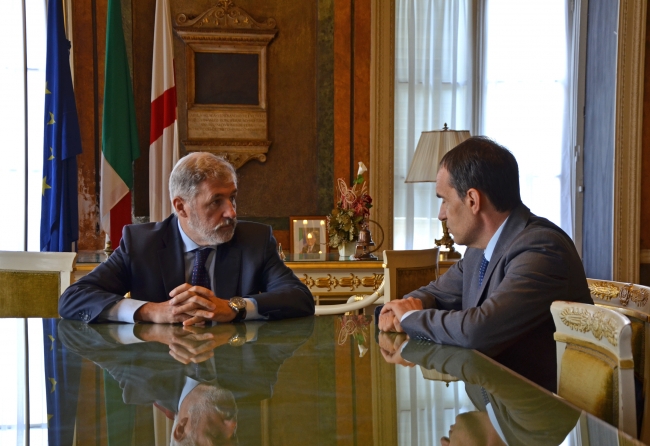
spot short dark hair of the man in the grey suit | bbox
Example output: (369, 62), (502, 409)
(440, 136), (521, 212)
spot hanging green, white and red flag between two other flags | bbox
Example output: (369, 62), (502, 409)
(99, 0), (140, 249)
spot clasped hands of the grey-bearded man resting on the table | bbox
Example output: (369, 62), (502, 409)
(135, 283), (236, 325)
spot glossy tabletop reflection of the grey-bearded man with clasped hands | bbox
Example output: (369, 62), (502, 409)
(59, 318), (314, 445)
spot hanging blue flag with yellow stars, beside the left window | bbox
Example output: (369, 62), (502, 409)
(41, 0), (81, 252)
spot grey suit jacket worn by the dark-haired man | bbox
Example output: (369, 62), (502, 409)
(402, 204), (593, 391)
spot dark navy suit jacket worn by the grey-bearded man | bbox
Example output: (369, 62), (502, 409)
(59, 215), (314, 322)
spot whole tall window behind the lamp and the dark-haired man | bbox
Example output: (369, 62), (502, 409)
(394, 0), (578, 249)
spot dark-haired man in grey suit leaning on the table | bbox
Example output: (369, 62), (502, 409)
(379, 137), (593, 391)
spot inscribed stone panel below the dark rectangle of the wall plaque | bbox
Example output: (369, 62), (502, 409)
(188, 109), (266, 139)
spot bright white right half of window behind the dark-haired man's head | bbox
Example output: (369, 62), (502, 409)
(479, 0), (573, 236)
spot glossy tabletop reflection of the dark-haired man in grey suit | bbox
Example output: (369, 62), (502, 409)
(378, 333), (580, 446)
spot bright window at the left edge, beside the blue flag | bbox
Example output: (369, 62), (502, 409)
(0, 0), (46, 251)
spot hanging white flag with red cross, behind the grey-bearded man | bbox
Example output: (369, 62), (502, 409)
(149, 0), (178, 221)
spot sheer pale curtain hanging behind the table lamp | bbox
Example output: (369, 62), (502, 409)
(393, 0), (472, 249)
